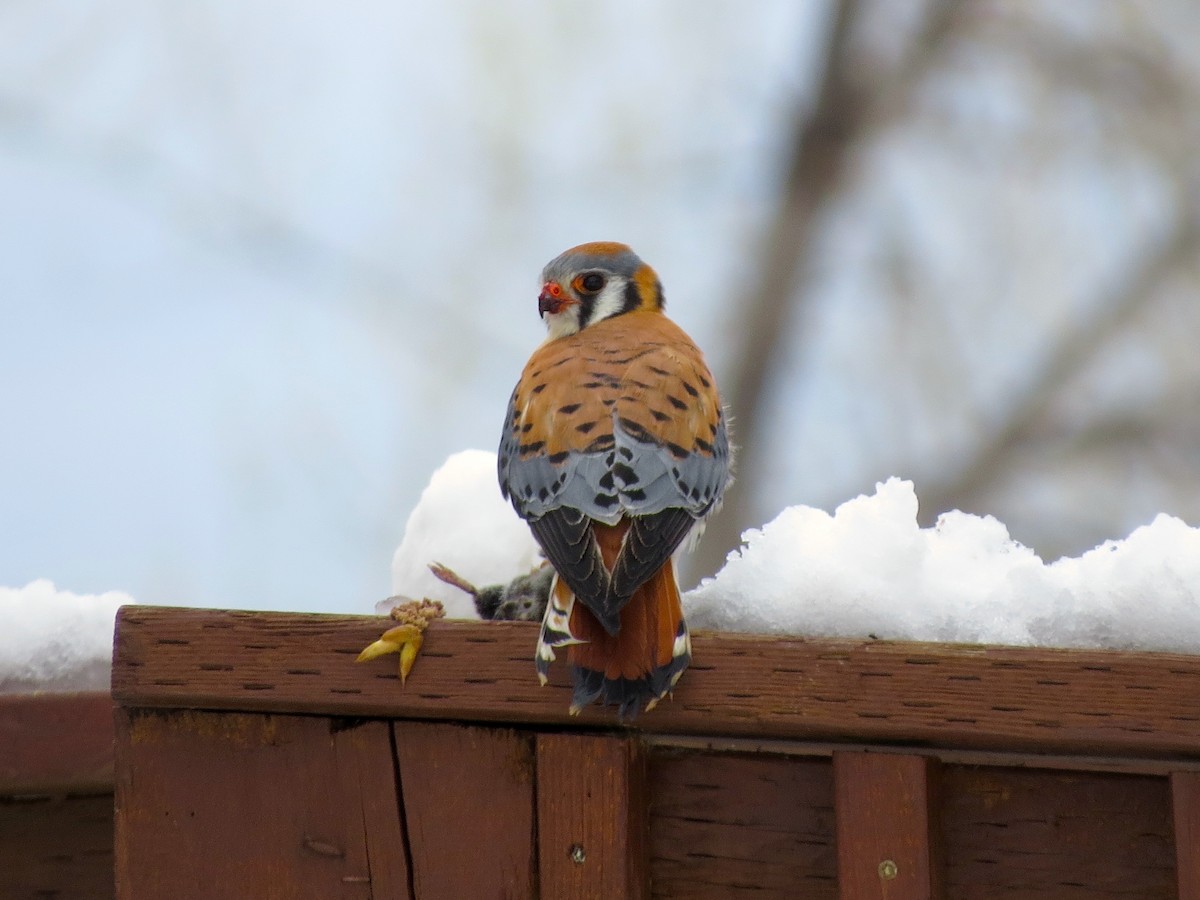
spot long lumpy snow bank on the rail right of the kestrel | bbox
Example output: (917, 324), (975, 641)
(684, 479), (1200, 653)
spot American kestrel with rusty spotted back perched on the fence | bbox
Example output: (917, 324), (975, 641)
(499, 242), (731, 716)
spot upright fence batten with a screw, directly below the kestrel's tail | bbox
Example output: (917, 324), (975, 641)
(538, 734), (650, 900)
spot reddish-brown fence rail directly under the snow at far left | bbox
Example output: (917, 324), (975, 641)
(0, 691), (113, 794)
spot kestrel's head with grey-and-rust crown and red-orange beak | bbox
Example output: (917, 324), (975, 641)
(538, 241), (664, 338)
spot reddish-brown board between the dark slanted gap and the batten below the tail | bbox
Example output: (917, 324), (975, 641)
(392, 721), (536, 900)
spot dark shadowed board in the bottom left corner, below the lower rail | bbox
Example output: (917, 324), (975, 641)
(0, 794), (113, 900)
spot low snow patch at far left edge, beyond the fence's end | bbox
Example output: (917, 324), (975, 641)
(0, 578), (133, 694)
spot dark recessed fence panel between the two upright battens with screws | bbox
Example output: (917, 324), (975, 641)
(648, 750), (838, 900)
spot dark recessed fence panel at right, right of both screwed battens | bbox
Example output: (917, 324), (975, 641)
(940, 766), (1176, 900)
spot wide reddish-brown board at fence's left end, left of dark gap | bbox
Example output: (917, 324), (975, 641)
(115, 709), (410, 900)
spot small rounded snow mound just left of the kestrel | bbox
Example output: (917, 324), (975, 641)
(391, 450), (541, 619)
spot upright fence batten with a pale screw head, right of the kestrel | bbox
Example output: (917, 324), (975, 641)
(833, 752), (942, 900)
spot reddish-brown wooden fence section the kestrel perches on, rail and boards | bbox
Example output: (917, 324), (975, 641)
(113, 607), (1200, 900)
